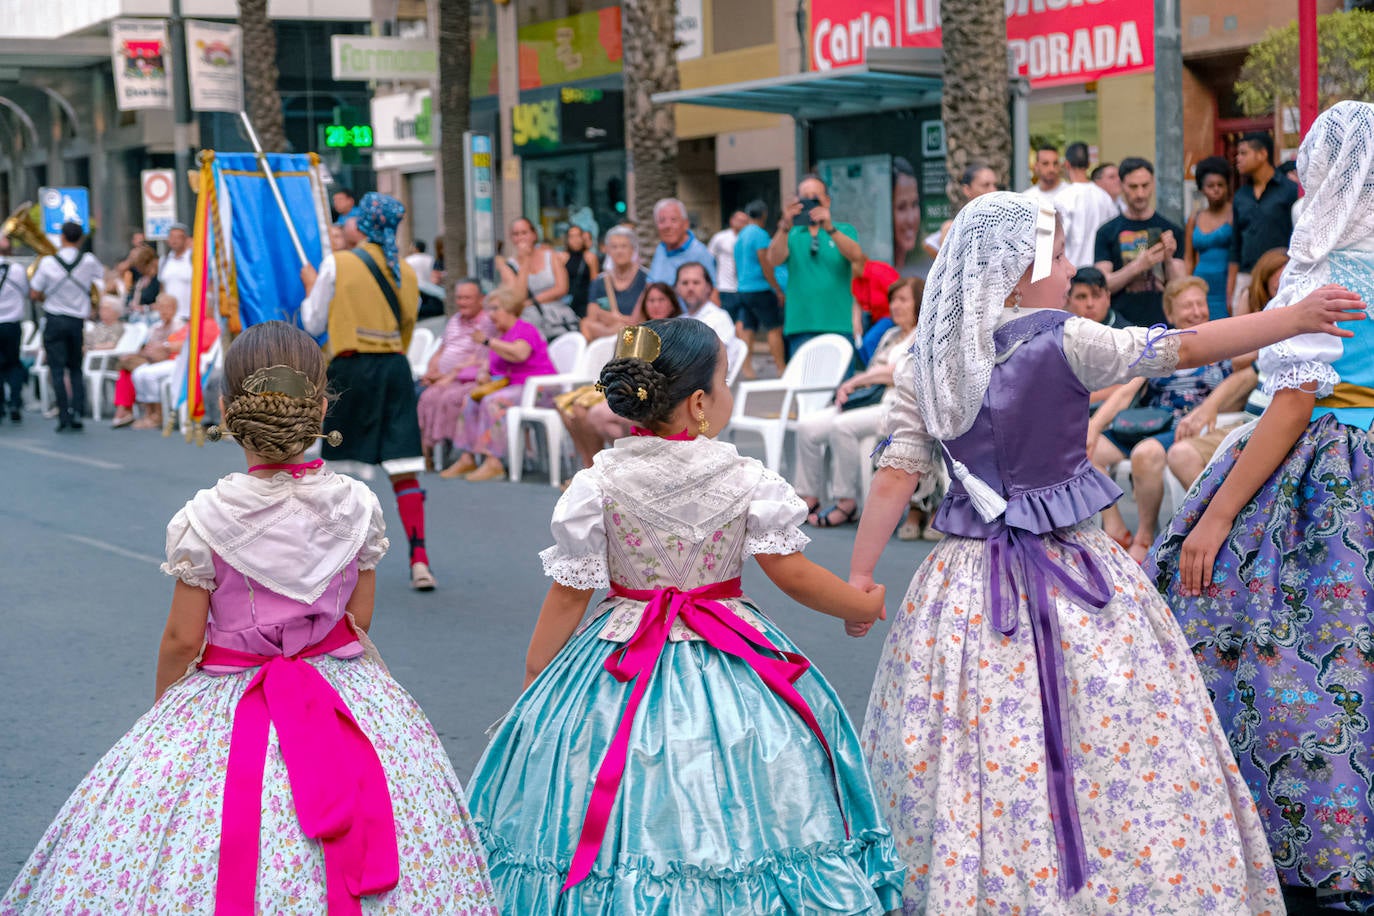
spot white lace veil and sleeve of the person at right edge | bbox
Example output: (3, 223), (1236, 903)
(1259, 102), (1374, 398)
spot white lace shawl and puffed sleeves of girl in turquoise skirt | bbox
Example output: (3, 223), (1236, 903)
(539, 437), (811, 589)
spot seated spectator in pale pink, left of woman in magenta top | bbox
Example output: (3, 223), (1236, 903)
(418, 280), (496, 470)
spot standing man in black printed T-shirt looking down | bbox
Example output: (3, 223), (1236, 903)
(1094, 157), (1189, 327)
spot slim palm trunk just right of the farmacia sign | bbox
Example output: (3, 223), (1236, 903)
(438, 0), (473, 310)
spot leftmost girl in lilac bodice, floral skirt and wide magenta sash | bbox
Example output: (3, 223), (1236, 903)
(0, 321), (496, 916)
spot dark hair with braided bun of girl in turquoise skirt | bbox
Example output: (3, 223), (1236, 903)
(600, 317), (720, 433)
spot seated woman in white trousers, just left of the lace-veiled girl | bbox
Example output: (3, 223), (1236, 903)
(793, 280), (921, 527)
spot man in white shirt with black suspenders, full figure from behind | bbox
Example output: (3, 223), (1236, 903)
(29, 222), (104, 433)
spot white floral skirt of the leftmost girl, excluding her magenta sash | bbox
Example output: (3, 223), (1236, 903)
(0, 656), (496, 916)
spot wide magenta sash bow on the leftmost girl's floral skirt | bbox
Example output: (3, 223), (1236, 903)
(201, 621), (400, 916)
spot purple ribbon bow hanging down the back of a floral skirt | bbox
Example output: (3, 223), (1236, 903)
(988, 529), (1112, 895)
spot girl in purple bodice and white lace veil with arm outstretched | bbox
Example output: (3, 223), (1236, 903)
(849, 192), (1363, 916)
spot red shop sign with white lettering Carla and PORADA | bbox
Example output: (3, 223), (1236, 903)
(811, 0), (1154, 87)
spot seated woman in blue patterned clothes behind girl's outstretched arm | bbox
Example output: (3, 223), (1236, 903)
(1088, 276), (1254, 562)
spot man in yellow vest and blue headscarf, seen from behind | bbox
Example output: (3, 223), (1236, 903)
(301, 192), (434, 592)
